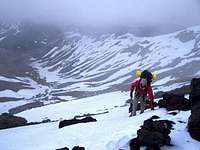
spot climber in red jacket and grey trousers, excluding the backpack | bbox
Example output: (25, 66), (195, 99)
(130, 78), (154, 116)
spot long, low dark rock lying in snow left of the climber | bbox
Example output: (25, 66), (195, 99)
(59, 117), (97, 128)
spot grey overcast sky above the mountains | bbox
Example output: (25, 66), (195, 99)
(0, 0), (200, 26)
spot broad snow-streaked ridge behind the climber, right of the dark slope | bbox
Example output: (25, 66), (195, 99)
(32, 26), (200, 96)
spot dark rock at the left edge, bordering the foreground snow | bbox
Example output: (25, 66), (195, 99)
(0, 113), (27, 129)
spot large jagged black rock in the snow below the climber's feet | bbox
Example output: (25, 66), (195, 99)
(130, 117), (174, 150)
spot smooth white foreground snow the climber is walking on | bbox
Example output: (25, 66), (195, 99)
(0, 92), (200, 150)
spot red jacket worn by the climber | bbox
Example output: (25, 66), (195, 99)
(131, 79), (154, 102)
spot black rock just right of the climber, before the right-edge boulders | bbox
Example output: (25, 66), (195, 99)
(158, 93), (191, 111)
